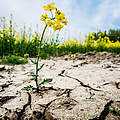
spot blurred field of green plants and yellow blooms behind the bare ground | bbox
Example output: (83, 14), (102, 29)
(0, 15), (120, 59)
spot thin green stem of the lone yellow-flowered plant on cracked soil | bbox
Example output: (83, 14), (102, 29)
(35, 25), (47, 90)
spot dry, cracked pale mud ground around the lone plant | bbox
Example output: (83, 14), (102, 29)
(0, 52), (120, 120)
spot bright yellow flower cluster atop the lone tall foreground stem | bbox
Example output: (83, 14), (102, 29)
(40, 3), (68, 31)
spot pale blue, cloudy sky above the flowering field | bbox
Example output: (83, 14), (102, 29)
(0, 0), (120, 40)
